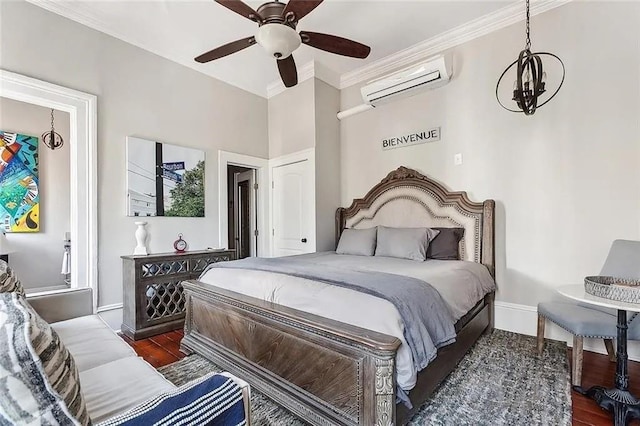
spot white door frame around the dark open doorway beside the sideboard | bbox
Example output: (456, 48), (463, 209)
(218, 150), (271, 257)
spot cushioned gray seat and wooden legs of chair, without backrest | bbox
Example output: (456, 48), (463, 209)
(538, 300), (617, 386)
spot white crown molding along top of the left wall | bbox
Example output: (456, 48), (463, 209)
(26, 0), (266, 98)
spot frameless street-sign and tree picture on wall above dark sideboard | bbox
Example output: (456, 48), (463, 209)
(127, 137), (204, 217)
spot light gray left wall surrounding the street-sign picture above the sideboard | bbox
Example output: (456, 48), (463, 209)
(0, 2), (268, 328)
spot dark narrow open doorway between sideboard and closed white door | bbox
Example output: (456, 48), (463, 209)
(227, 165), (258, 259)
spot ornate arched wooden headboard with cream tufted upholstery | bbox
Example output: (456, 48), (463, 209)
(336, 167), (495, 275)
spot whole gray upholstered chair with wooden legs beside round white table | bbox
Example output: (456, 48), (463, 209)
(538, 240), (640, 386)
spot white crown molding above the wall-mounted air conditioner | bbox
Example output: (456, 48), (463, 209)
(336, 0), (571, 89)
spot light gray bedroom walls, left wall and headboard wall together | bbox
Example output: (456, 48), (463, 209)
(0, 2), (640, 326)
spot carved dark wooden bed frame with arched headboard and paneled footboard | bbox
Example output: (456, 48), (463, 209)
(181, 167), (495, 425)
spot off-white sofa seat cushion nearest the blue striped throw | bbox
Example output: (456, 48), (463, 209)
(80, 356), (175, 423)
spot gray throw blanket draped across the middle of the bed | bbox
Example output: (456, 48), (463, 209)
(202, 257), (456, 371)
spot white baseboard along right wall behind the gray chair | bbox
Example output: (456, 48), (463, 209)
(495, 301), (640, 361)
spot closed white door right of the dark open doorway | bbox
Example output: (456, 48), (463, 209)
(272, 160), (316, 256)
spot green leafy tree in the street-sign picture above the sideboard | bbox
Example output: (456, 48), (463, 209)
(164, 161), (204, 217)
